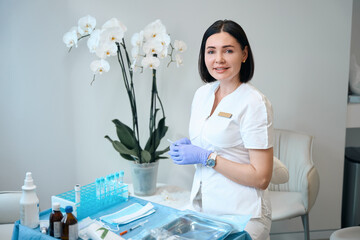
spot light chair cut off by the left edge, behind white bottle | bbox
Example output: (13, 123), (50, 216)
(0, 191), (21, 240)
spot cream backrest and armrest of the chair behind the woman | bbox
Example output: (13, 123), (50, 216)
(269, 129), (319, 210)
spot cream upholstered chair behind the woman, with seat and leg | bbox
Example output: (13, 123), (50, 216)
(268, 129), (320, 240)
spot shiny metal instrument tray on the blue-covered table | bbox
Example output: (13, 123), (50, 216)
(143, 214), (232, 240)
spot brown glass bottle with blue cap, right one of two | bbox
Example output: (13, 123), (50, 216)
(61, 206), (79, 240)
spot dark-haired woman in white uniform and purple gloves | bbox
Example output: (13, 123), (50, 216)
(169, 20), (273, 240)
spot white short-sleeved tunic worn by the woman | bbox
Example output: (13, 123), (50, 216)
(189, 82), (273, 218)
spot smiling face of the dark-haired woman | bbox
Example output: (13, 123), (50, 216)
(204, 32), (247, 82)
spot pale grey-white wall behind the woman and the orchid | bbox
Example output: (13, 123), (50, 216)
(0, 0), (352, 237)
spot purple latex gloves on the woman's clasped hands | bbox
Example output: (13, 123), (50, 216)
(169, 142), (212, 166)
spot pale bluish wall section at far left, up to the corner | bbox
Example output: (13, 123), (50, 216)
(0, 1), (76, 209)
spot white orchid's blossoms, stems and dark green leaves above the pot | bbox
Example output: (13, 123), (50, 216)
(63, 15), (187, 163)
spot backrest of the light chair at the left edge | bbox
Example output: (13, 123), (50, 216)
(0, 191), (22, 224)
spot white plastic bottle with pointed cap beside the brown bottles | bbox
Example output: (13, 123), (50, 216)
(20, 172), (40, 228)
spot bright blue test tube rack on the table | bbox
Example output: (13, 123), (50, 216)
(51, 173), (129, 220)
